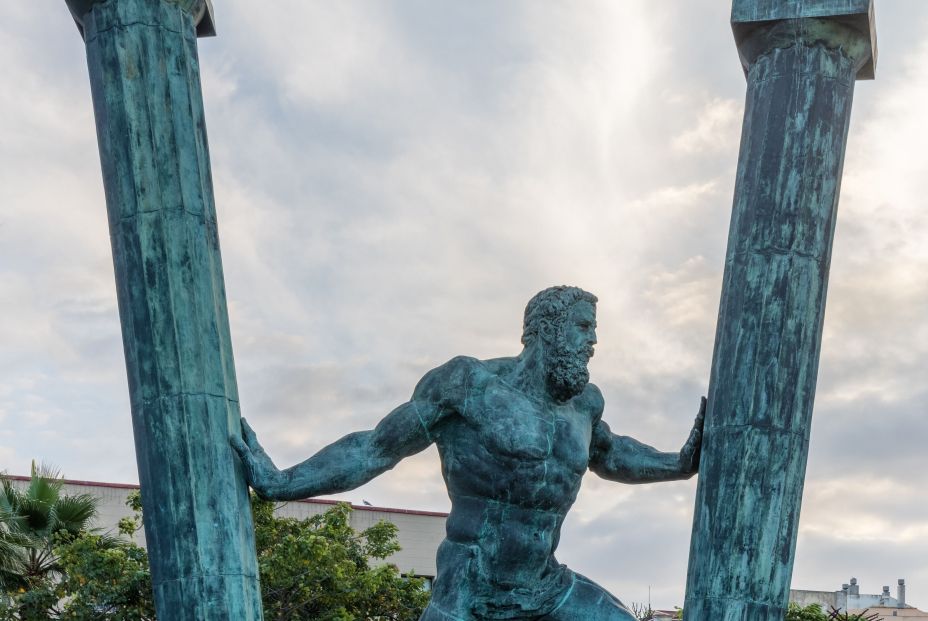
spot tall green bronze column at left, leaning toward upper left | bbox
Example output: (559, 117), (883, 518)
(67, 0), (262, 621)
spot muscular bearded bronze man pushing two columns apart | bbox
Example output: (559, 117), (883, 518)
(232, 286), (705, 621)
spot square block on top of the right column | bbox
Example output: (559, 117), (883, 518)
(731, 0), (877, 80)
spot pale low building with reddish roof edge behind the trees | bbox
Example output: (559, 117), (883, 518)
(5, 475), (448, 585)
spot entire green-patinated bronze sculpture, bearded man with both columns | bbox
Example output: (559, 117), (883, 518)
(63, 0), (873, 621)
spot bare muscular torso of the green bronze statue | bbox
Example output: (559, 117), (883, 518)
(435, 356), (600, 618)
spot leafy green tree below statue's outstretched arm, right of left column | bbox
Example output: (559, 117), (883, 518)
(252, 498), (428, 621)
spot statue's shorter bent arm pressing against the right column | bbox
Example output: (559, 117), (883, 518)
(590, 397), (706, 483)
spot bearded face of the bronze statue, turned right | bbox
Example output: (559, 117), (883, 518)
(545, 301), (596, 402)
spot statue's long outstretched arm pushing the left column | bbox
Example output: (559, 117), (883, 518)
(231, 358), (466, 500)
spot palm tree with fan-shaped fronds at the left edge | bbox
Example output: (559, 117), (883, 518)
(0, 462), (98, 588)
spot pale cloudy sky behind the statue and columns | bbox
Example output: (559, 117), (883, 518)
(0, 0), (928, 609)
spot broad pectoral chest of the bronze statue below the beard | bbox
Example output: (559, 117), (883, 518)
(478, 382), (591, 471)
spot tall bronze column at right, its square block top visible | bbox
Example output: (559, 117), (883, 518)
(684, 0), (876, 621)
